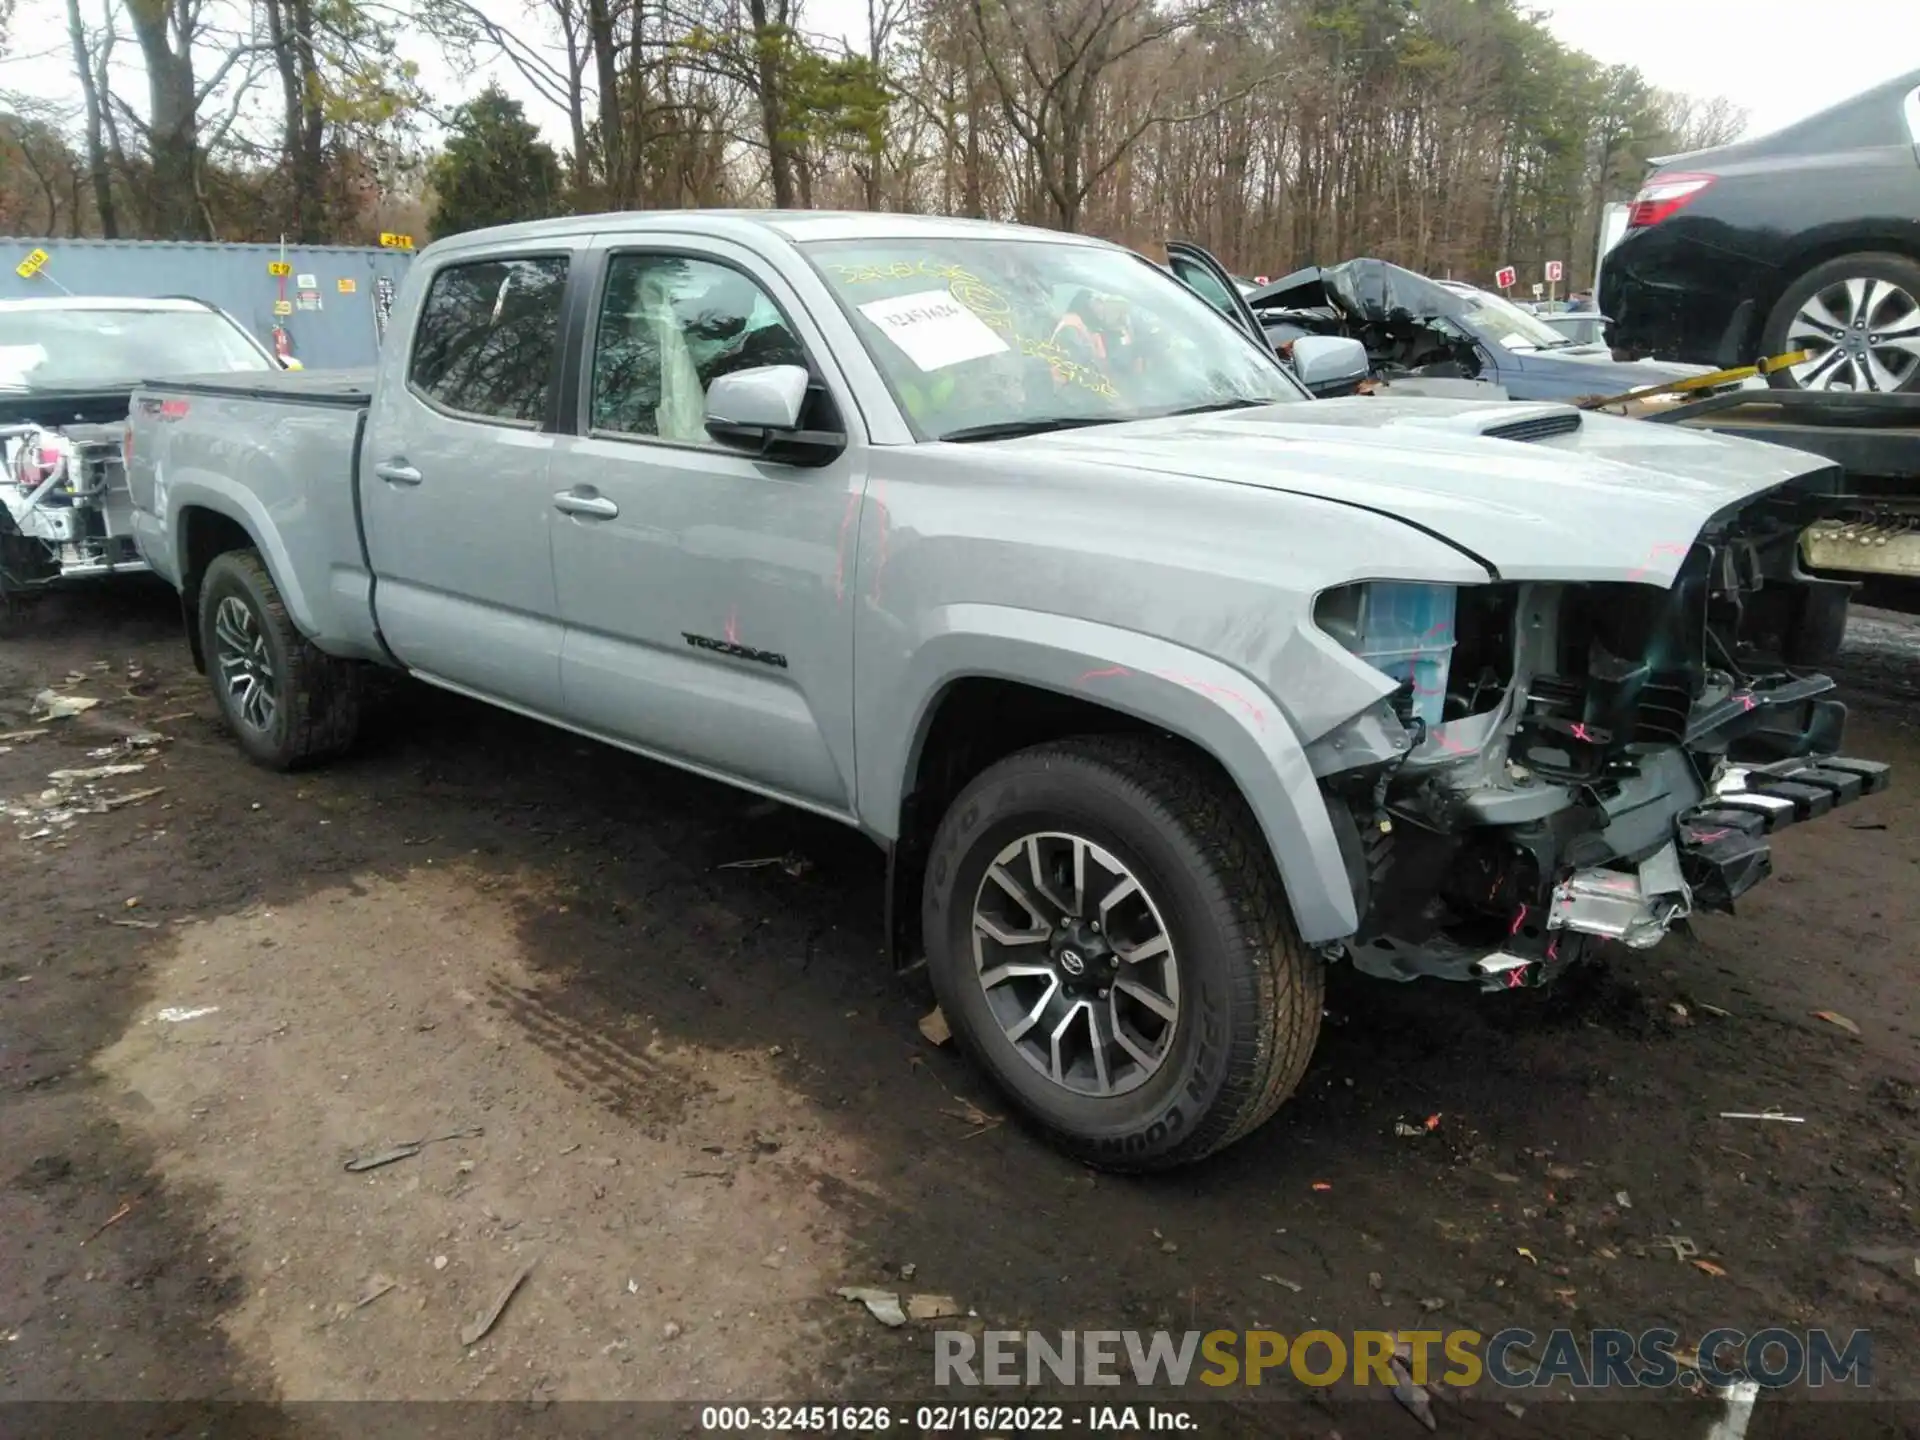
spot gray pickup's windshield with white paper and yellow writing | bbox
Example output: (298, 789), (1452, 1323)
(803, 236), (1306, 440)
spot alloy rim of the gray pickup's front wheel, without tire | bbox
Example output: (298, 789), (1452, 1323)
(973, 831), (1181, 1098)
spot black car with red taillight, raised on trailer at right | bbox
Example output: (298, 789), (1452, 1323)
(1599, 71), (1920, 392)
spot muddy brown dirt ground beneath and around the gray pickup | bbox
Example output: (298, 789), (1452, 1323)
(0, 586), (1920, 1440)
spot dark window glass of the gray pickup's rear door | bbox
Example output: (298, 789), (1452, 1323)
(407, 255), (566, 424)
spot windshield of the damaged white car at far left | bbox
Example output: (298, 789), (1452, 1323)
(0, 309), (275, 390)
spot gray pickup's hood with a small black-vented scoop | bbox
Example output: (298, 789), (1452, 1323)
(983, 396), (1839, 588)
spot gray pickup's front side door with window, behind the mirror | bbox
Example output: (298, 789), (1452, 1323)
(549, 240), (864, 816)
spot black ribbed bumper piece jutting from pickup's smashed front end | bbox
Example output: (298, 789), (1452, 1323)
(1676, 756), (1893, 912)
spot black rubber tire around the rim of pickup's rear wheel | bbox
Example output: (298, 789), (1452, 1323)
(200, 549), (361, 770)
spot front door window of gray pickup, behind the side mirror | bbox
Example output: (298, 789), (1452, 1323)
(589, 255), (826, 445)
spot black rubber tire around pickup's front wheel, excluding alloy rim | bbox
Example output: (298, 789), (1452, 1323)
(922, 735), (1325, 1171)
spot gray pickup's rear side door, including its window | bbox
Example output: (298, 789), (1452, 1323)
(359, 257), (574, 714)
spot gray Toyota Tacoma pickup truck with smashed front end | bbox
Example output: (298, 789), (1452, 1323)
(129, 213), (1887, 1169)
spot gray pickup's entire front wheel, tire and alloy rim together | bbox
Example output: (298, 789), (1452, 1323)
(924, 735), (1325, 1169)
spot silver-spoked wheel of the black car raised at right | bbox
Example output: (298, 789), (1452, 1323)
(1761, 253), (1920, 394)
